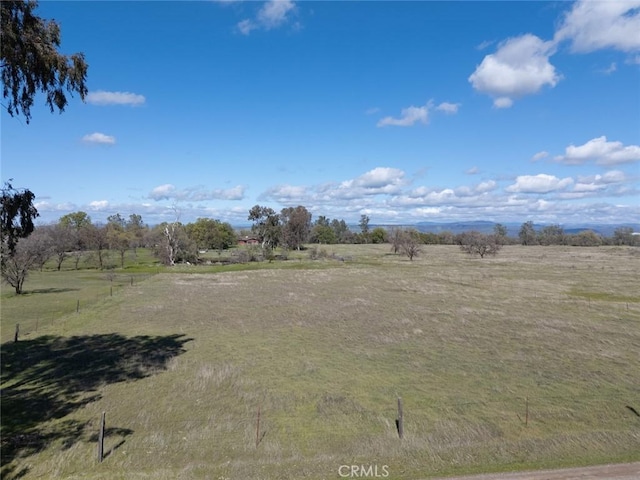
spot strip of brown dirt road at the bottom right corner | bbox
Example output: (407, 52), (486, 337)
(434, 462), (640, 480)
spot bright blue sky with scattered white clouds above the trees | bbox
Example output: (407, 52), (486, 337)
(2, 0), (640, 225)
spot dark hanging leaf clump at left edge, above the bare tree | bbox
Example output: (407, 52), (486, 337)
(0, 180), (39, 255)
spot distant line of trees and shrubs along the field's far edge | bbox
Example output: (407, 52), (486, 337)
(1, 189), (640, 294)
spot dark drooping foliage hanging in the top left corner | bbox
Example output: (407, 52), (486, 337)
(0, 0), (88, 123)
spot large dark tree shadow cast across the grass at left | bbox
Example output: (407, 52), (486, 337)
(0, 333), (191, 478)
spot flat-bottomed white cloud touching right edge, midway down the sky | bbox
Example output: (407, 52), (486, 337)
(555, 135), (640, 165)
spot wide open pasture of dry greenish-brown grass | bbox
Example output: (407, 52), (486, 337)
(2, 245), (640, 480)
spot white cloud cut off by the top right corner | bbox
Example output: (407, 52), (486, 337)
(554, 0), (640, 53)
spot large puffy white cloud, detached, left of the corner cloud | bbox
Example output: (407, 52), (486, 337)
(468, 34), (561, 108)
